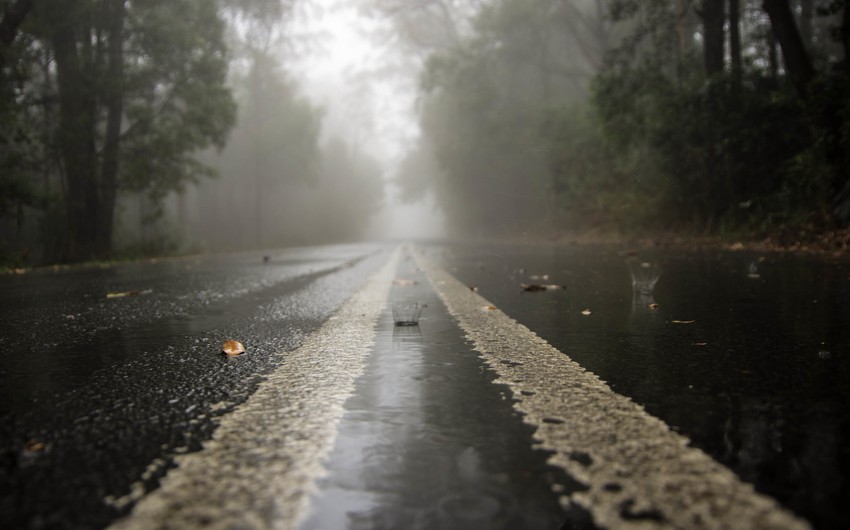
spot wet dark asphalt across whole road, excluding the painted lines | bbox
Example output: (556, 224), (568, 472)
(0, 240), (850, 528)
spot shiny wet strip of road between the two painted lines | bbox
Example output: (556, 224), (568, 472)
(301, 268), (589, 530)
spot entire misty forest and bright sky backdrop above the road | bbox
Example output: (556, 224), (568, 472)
(0, 0), (850, 267)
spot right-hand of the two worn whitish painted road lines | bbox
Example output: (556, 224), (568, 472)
(414, 249), (809, 529)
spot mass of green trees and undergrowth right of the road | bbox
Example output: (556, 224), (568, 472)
(401, 0), (850, 235)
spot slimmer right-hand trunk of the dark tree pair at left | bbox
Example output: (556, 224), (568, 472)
(97, 0), (126, 256)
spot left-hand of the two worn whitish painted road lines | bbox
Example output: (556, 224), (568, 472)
(111, 245), (400, 530)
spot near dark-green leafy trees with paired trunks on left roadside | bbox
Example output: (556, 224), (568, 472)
(0, 0), (248, 261)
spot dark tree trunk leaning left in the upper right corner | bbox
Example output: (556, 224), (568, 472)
(762, 0), (815, 98)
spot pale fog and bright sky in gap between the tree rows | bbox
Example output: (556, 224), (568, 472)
(165, 0), (444, 251)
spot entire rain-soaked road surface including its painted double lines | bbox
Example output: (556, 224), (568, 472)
(0, 241), (848, 528)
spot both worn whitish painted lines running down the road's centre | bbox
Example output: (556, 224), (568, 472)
(113, 244), (808, 530)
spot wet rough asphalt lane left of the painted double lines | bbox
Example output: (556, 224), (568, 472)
(0, 245), (388, 528)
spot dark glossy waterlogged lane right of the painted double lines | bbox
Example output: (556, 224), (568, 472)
(441, 247), (850, 528)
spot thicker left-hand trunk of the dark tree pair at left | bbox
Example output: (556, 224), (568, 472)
(51, 20), (99, 261)
